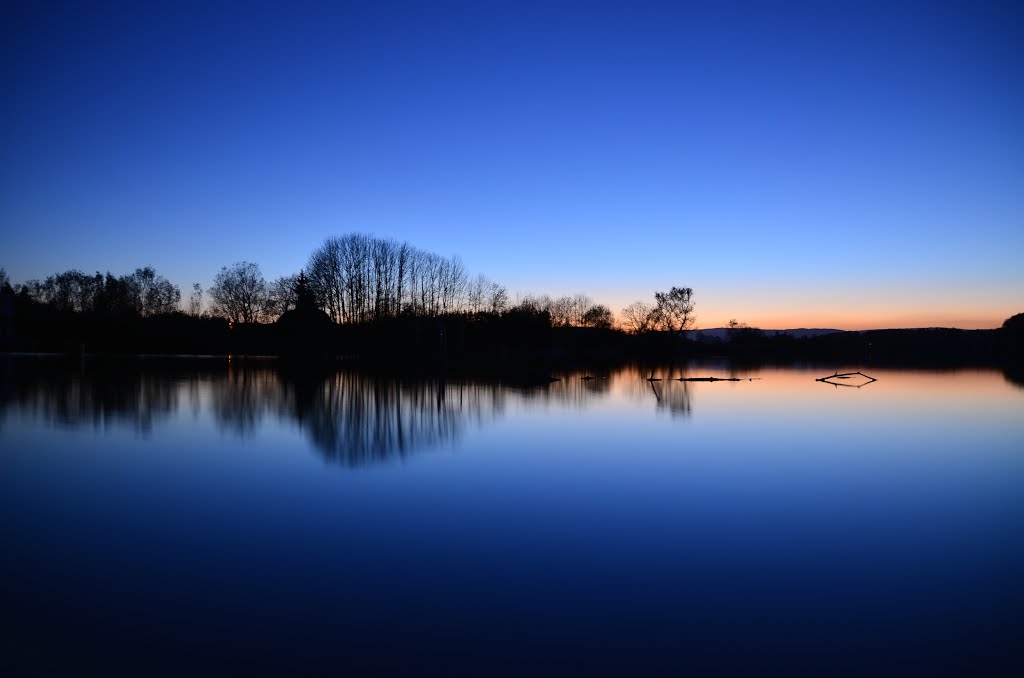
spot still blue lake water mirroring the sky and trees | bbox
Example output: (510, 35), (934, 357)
(0, 358), (1024, 675)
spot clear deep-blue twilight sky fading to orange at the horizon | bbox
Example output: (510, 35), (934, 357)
(0, 0), (1024, 329)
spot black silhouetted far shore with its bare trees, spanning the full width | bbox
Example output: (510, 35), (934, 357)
(0, 234), (1024, 372)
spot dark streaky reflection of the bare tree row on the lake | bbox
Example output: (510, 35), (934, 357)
(0, 358), (720, 466)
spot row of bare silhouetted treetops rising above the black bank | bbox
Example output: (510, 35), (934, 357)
(0, 234), (694, 334)
